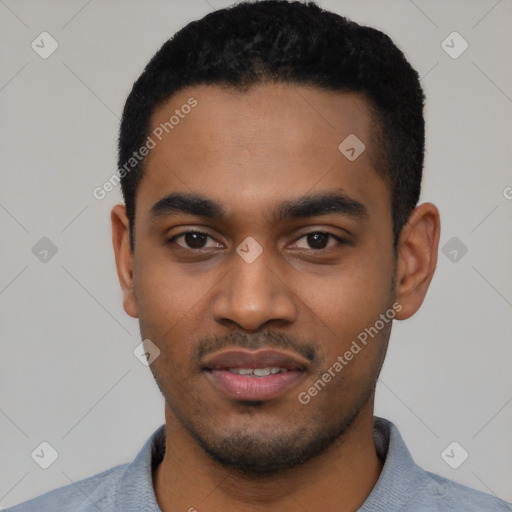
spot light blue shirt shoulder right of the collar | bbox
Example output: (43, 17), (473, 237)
(418, 471), (512, 512)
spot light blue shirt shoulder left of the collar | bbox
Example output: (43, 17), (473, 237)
(4, 464), (128, 512)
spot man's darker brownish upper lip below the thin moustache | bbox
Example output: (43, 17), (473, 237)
(201, 349), (309, 370)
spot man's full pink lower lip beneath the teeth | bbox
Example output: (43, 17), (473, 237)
(207, 370), (304, 402)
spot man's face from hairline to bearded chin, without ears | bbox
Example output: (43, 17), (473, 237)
(118, 84), (402, 473)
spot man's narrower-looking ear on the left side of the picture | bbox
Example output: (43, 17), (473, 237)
(110, 204), (139, 318)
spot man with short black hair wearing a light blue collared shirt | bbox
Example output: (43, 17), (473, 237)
(6, 1), (511, 512)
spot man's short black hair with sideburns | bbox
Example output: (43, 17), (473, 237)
(118, 0), (425, 250)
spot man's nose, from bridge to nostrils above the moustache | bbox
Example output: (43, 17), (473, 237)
(213, 251), (297, 331)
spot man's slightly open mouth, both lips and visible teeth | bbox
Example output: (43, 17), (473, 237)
(201, 349), (310, 402)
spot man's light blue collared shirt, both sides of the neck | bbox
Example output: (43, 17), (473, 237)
(5, 417), (512, 512)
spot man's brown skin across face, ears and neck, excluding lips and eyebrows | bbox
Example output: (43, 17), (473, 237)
(112, 84), (440, 512)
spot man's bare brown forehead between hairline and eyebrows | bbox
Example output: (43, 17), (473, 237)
(138, 84), (388, 224)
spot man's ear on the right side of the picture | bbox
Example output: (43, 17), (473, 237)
(396, 203), (441, 320)
